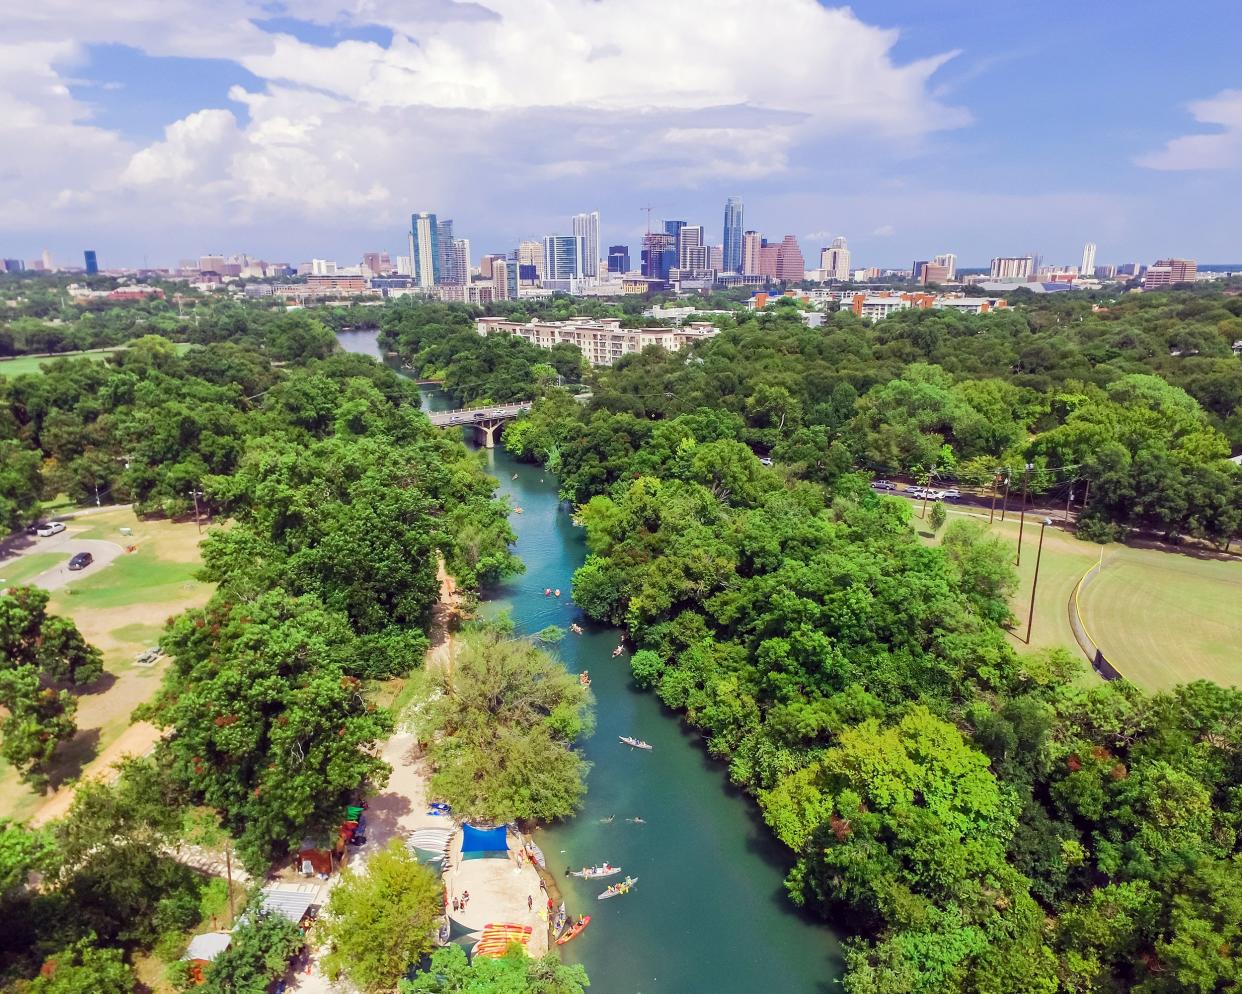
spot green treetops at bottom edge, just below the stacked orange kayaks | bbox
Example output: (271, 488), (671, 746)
(399, 946), (590, 994)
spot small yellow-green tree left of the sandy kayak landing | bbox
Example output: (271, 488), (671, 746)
(317, 839), (443, 992)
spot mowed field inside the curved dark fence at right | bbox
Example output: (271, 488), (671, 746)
(1079, 547), (1242, 690)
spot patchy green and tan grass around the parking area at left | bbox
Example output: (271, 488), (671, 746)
(0, 508), (211, 819)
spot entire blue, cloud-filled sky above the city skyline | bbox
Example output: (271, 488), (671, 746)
(0, 0), (1242, 267)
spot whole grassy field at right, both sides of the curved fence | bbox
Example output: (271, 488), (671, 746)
(914, 496), (1242, 690)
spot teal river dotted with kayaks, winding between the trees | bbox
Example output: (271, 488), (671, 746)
(340, 332), (841, 994)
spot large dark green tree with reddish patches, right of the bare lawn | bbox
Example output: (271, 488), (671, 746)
(156, 589), (392, 871)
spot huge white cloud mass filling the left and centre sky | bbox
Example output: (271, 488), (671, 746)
(0, 0), (969, 248)
